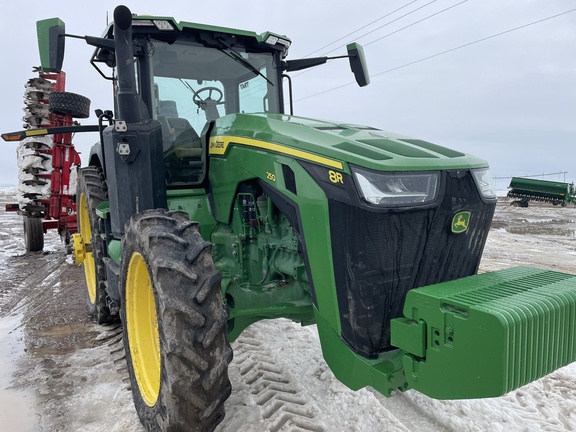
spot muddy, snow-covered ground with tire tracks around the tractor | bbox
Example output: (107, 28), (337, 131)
(0, 193), (576, 432)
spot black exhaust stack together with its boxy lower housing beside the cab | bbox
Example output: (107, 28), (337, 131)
(102, 6), (167, 238)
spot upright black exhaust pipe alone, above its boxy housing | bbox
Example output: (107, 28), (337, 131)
(114, 5), (142, 123)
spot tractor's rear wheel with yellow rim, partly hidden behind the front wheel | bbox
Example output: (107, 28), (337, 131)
(76, 166), (117, 324)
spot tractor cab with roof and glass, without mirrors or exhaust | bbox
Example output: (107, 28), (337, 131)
(92, 16), (290, 188)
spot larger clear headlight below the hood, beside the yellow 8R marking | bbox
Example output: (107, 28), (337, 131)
(352, 168), (440, 207)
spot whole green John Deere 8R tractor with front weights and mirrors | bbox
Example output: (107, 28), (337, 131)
(5, 6), (576, 431)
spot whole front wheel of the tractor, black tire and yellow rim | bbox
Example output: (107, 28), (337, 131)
(120, 209), (232, 432)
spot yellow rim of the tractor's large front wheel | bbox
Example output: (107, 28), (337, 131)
(125, 252), (160, 407)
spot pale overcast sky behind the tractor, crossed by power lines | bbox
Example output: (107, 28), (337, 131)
(0, 0), (576, 189)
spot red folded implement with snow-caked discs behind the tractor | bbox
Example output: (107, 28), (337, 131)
(5, 68), (90, 252)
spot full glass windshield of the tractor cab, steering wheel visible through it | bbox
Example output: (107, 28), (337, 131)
(148, 41), (281, 185)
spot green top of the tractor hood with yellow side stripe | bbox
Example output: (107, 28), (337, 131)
(210, 114), (488, 172)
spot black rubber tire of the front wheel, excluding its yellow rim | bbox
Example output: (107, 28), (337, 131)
(121, 209), (232, 432)
